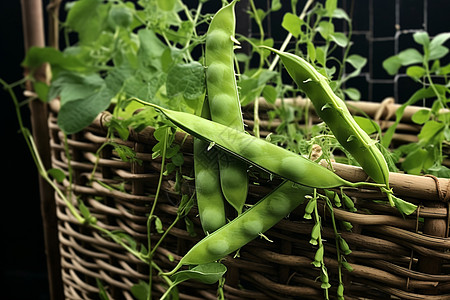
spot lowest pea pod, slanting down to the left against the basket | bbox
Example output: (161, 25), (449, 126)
(162, 181), (313, 275)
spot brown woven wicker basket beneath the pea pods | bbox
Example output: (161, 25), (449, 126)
(49, 99), (450, 300)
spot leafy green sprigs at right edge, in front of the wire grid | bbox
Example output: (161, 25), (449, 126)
(381, 31), (450, 178)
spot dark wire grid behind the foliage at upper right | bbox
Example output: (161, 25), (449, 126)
(238, 0), (450, 105)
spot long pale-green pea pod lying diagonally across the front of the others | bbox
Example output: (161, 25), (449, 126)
(142, 100), (379, 188)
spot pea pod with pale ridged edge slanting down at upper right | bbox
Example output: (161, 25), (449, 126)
(264, 47), (389, 192)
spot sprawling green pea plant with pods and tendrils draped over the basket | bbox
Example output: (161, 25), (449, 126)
(2, 0), (426, 300)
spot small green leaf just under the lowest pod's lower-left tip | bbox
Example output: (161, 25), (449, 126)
(170, 262), (227, 285)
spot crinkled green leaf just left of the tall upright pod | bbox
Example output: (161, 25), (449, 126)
(166, 62), (205, 100)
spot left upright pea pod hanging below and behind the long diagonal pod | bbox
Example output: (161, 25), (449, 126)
(194, 101), (226, 233)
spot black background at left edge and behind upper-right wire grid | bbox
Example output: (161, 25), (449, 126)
(0, 0), (450, 300)
